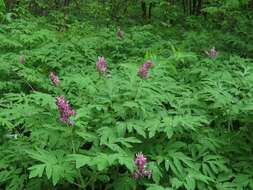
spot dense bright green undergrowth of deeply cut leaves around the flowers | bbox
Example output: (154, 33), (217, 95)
(0, 20), (253, 190)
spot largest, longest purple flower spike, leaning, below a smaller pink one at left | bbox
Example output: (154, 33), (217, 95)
(56, 96), (76, 125)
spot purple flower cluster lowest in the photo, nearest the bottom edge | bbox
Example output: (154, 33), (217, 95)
(133, 153), (152, 179)
